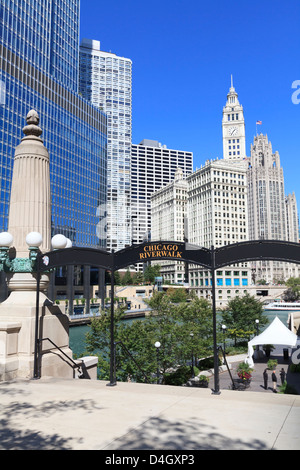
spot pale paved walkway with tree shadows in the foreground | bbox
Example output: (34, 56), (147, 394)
(0, 346), (300, 450)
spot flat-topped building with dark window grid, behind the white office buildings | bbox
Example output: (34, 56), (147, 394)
(131, 139), (193, 258)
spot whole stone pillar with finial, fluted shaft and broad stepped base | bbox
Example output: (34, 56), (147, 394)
(0, 110), (73, 381)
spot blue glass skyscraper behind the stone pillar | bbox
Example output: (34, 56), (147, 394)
(0, 0), (107, 248)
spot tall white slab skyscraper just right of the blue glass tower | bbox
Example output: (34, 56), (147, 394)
(79, 39), (132, 251)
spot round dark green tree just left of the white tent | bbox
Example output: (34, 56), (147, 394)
(222, 293), (269, 344)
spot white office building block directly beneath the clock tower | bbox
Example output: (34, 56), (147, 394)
(187, 160), (251, 307)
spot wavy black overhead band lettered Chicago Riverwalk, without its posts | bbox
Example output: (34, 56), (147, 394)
(37, 240), (300, 272)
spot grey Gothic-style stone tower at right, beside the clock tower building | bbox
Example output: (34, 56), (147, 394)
(247, 134), (299, 283)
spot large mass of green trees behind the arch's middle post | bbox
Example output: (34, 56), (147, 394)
(86, 292), (213, 382)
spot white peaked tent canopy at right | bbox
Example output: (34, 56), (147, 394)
(246, 317), (298, 366)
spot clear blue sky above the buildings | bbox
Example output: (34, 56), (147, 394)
(80, 0), (300, 202)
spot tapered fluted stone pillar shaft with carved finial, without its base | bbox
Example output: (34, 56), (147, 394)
(8, 110), (51, 258)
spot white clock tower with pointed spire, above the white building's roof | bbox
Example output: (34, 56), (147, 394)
(222, 75), (246, 160)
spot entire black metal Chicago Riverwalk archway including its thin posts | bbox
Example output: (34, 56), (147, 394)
(34, 240), (300, 394)
